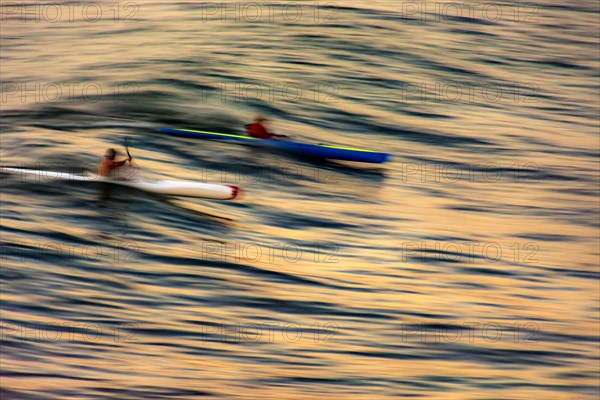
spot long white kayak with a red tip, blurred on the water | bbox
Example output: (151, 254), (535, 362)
(0, 168), (241, 200)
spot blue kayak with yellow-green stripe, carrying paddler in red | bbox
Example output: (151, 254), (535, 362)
(160, 128), (391, 164)
